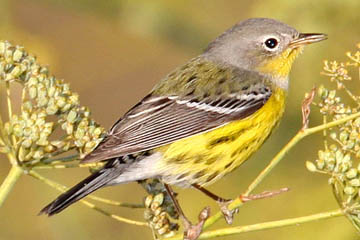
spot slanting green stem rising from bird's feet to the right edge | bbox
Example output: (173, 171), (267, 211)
(203, 112), (360, 229)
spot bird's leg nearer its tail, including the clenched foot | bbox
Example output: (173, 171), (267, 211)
(164, 184), (210, 240)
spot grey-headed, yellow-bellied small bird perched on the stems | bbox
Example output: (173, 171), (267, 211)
(40, 18), (327, 239)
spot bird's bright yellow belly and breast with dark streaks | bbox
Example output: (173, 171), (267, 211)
(158, 89), (286, 186)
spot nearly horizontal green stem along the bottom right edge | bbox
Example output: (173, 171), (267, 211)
(166, 209), (345, 240)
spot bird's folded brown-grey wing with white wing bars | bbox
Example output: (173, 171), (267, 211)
(83, 84), (271, 162)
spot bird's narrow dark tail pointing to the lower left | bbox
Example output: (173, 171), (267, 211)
(39, 161), (121, 216)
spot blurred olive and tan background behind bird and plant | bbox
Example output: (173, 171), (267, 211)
(0, 0), (360, 240)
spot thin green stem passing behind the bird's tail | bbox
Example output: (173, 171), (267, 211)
(28, 170), (148, 226)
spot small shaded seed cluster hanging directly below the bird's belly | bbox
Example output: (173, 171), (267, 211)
(142, 179), (179, 238)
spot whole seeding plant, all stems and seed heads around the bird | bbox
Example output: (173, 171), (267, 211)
(0, 41), (360, 240)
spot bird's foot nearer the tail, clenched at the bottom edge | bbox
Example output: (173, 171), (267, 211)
(183, 207), (210, 240)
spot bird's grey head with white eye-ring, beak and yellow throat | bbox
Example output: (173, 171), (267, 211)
(203, 18), (326, 79)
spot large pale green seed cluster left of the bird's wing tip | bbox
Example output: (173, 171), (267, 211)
(0, 41), (104, 161)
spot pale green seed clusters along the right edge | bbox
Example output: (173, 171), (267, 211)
(306, 45), (360, 231)
